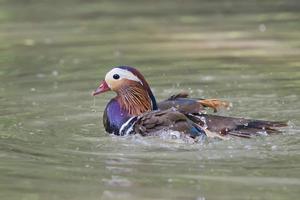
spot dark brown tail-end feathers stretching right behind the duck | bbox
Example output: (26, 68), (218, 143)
(187, 114), (287, 138)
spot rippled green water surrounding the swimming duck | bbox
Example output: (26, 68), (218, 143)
(0, 0), (300, 200)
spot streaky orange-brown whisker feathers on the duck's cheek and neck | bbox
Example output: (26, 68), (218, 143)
(117, 82), (152, 116)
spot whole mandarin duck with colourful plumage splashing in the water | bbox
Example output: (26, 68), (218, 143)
(92, 66), (287, 139)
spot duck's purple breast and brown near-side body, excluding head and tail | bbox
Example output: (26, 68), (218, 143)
(103, 94), (205, 139)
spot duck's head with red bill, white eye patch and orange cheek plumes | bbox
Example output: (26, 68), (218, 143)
(92, 66), (157, 116)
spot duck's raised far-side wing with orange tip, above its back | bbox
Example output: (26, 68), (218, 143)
(158, 92), (230, 114)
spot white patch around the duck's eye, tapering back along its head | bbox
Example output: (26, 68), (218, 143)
(105, 68), (143, 87)
